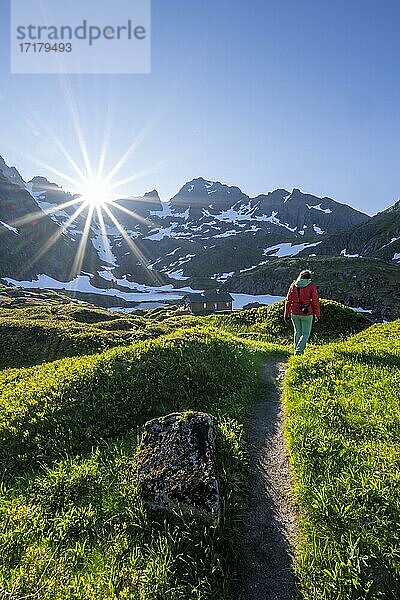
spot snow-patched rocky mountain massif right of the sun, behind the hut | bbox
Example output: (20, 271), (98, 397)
(144, 178), (369, 280)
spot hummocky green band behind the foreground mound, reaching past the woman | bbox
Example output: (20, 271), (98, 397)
(0, 297), (370, 369)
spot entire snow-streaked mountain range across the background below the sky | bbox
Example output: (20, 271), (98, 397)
(0, 152), (400, 316)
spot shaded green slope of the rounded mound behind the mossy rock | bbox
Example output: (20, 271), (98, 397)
(0, 332), (256, 476)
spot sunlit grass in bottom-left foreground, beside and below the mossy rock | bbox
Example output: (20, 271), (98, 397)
(0, 424), (241, 600)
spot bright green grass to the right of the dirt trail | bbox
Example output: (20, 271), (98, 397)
(285, 321), (400, 600)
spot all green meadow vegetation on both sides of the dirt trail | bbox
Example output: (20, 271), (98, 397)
(0, 295), (400, 600)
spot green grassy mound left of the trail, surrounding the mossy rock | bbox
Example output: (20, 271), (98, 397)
(0, 330), (279, 600)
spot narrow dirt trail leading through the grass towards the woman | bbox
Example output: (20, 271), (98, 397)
(238, 358), (297, 600)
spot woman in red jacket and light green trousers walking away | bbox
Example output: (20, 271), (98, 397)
(284, 271), (320, 354)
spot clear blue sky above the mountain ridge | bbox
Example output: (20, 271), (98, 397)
(0, 0), (400, 214)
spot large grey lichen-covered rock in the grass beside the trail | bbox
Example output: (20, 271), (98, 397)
(138, 412), (221, 518)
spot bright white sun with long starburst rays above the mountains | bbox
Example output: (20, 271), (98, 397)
(2, 89), (165, 285)
